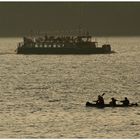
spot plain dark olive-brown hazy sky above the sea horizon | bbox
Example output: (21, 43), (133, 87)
(0, 2), (140, 36)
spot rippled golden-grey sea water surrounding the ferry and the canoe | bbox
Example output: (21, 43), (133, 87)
(0, 37), (140, 138)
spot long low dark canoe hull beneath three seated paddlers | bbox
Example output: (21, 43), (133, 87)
(86, 102), (138, 108)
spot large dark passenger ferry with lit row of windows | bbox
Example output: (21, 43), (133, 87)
(16, 34), (113, 54)
